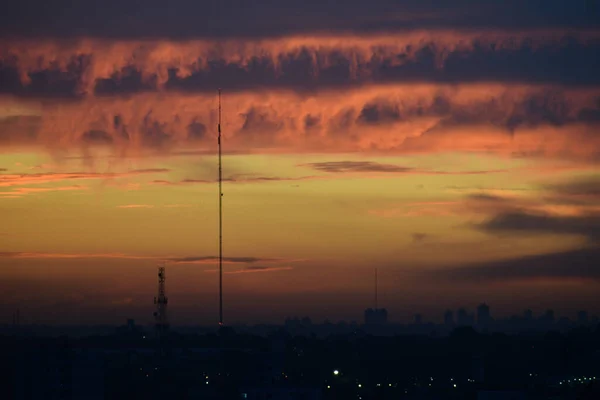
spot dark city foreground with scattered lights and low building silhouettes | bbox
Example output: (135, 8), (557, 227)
(0, 304), (600, 400)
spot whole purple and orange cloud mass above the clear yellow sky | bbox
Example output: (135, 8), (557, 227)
(0, 5), (600, 162)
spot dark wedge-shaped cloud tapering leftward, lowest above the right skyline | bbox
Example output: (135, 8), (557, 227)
(435, 248), (600, 282)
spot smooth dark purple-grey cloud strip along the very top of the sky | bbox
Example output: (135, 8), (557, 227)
(0, 0), (600, 39)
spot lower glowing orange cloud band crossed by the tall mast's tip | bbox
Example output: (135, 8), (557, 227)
(0, 83), (600, 162)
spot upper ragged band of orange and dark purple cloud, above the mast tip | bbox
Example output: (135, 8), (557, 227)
(0, 30), (600, 99)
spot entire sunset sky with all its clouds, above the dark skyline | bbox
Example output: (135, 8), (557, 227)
(0, 0), (600, 324)
